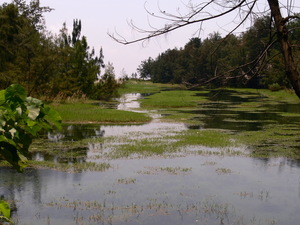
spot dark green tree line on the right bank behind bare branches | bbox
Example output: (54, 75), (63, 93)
(137, 15), (300, 90)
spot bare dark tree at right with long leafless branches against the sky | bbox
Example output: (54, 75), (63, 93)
(110, 0), (300, 98)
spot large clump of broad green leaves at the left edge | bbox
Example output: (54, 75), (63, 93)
(0, 84), (61, 172)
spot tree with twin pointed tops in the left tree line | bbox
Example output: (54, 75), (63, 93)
(52, 20), (104, 96)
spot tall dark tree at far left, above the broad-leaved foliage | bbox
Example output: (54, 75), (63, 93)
(0, 0), (53, 94)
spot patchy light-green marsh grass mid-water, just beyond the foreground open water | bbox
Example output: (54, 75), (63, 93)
(100, 127), (246, 159)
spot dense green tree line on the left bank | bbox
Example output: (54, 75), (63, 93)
(0, 0), (119, 99)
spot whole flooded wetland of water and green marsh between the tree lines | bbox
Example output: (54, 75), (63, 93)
(0, 83), (300, 225)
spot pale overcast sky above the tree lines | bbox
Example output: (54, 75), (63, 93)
(0, 0), (299, 77)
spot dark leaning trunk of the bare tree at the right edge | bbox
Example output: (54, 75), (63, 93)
(268, 0), (300, 98)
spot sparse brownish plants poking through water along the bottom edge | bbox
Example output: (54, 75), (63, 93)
(46, 195), (276, 225)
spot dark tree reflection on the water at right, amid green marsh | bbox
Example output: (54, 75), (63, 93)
(191, 90), (300, 131)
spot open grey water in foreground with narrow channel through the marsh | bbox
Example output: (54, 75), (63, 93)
(0, 94), (300, 225)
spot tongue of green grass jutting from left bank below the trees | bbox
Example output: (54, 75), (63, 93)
(53, 103), (151, 124)
